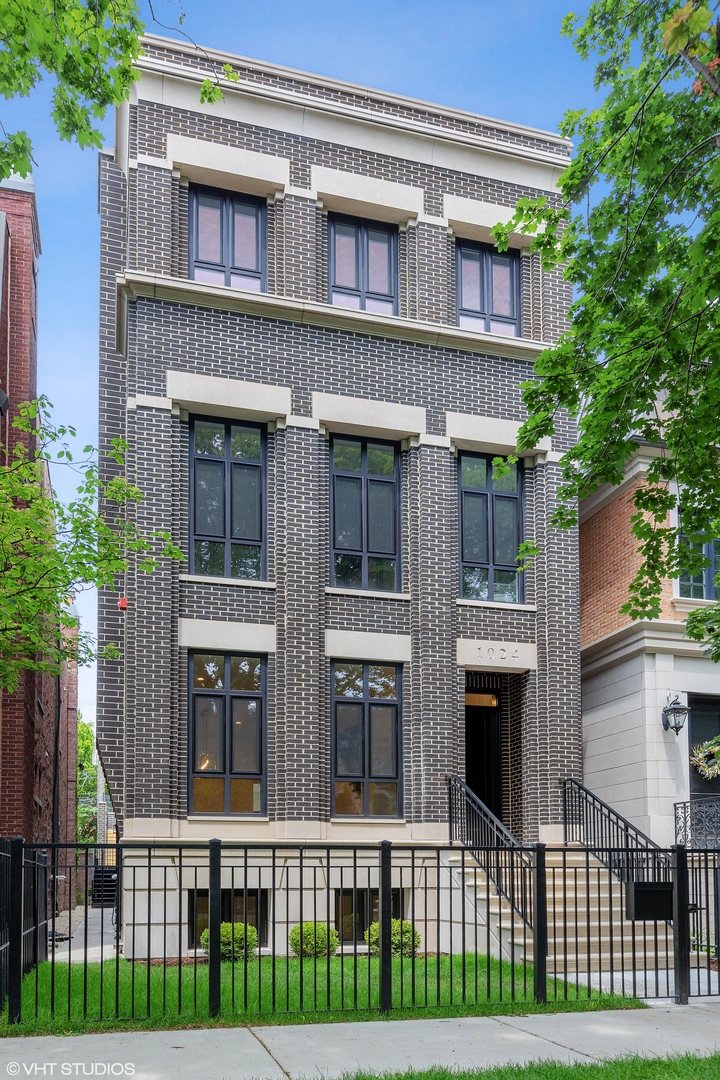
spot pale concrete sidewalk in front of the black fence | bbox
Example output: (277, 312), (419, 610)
(0, 1000), (720, 1080)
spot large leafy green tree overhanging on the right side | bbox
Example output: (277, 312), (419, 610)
(494, 0), (720, 661)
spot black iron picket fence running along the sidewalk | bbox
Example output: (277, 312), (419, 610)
(0, 840), (720, 1028)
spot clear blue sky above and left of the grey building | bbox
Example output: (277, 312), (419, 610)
(5, 0), (594, 719)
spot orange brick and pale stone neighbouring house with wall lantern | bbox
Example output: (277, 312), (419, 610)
(580, 447), (720, 847)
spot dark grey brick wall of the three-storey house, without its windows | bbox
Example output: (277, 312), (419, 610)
(98, 39), (582, 839)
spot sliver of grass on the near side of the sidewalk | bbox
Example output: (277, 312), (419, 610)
(347, 1054), (720, 1080)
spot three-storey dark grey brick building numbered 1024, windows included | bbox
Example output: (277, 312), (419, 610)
(98, 37), (582, 876)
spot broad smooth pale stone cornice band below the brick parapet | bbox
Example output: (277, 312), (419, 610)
(129, 56), (570, 191)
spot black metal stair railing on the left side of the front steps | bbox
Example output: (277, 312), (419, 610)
(447, 774), (533, 930)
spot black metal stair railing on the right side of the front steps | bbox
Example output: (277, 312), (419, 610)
(562, 778), (670, 881)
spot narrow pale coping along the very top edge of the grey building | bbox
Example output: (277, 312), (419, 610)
(136, 33), (572, 162)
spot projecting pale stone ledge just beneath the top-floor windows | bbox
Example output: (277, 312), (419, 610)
(117, 270), (548, 363)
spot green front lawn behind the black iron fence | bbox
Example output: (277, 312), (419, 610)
(0, 954), (640, 1035)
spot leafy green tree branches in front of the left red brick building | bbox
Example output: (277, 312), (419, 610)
(0, 399), (182, 690)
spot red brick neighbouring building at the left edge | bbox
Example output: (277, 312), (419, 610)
(0, 177), (78, 841)
